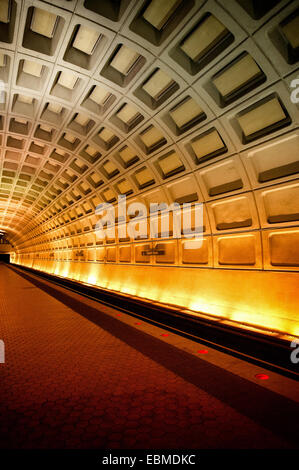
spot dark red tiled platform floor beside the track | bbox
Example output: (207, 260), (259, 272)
(0, 265), (298, 449)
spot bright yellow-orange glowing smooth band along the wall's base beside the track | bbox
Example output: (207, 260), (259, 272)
(14, 255), (299, 336)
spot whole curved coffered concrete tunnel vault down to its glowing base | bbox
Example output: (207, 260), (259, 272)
(0, 0), (299, 335)
